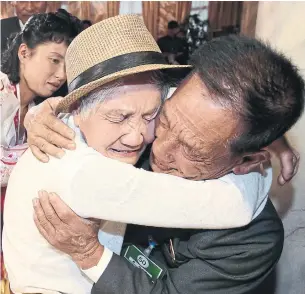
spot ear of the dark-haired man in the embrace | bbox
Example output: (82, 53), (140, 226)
(232, 150), (270, 175)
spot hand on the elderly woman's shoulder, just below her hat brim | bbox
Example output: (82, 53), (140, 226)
(24, 97), (75, 162)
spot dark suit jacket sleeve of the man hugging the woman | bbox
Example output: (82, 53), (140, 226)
(92, 201), (284, 294)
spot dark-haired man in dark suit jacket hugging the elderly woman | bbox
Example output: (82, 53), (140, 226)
(24, 33), (304, 294)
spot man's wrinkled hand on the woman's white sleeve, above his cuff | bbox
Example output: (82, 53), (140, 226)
(33, 191), (103, 269)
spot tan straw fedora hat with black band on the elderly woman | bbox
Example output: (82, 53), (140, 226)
(57, 15), (190, 112)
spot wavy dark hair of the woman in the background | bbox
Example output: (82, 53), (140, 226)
(1, 9), (83, 84)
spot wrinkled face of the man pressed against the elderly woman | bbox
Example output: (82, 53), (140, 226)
(151, 74), (238, 180)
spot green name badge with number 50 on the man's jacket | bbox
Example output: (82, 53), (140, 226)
(124, 245), (163, 280)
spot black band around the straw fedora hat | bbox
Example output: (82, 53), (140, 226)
(68, 51), (168, 92)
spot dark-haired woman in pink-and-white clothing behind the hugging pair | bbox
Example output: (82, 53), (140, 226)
(0, 10), (82, 292)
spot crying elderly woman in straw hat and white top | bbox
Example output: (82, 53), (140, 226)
(3, 16), (300, 293)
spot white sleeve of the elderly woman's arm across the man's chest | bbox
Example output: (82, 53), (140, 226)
(69, 154), (270, 229)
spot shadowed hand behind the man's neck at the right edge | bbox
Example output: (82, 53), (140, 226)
(267, 137), (300, 186)
